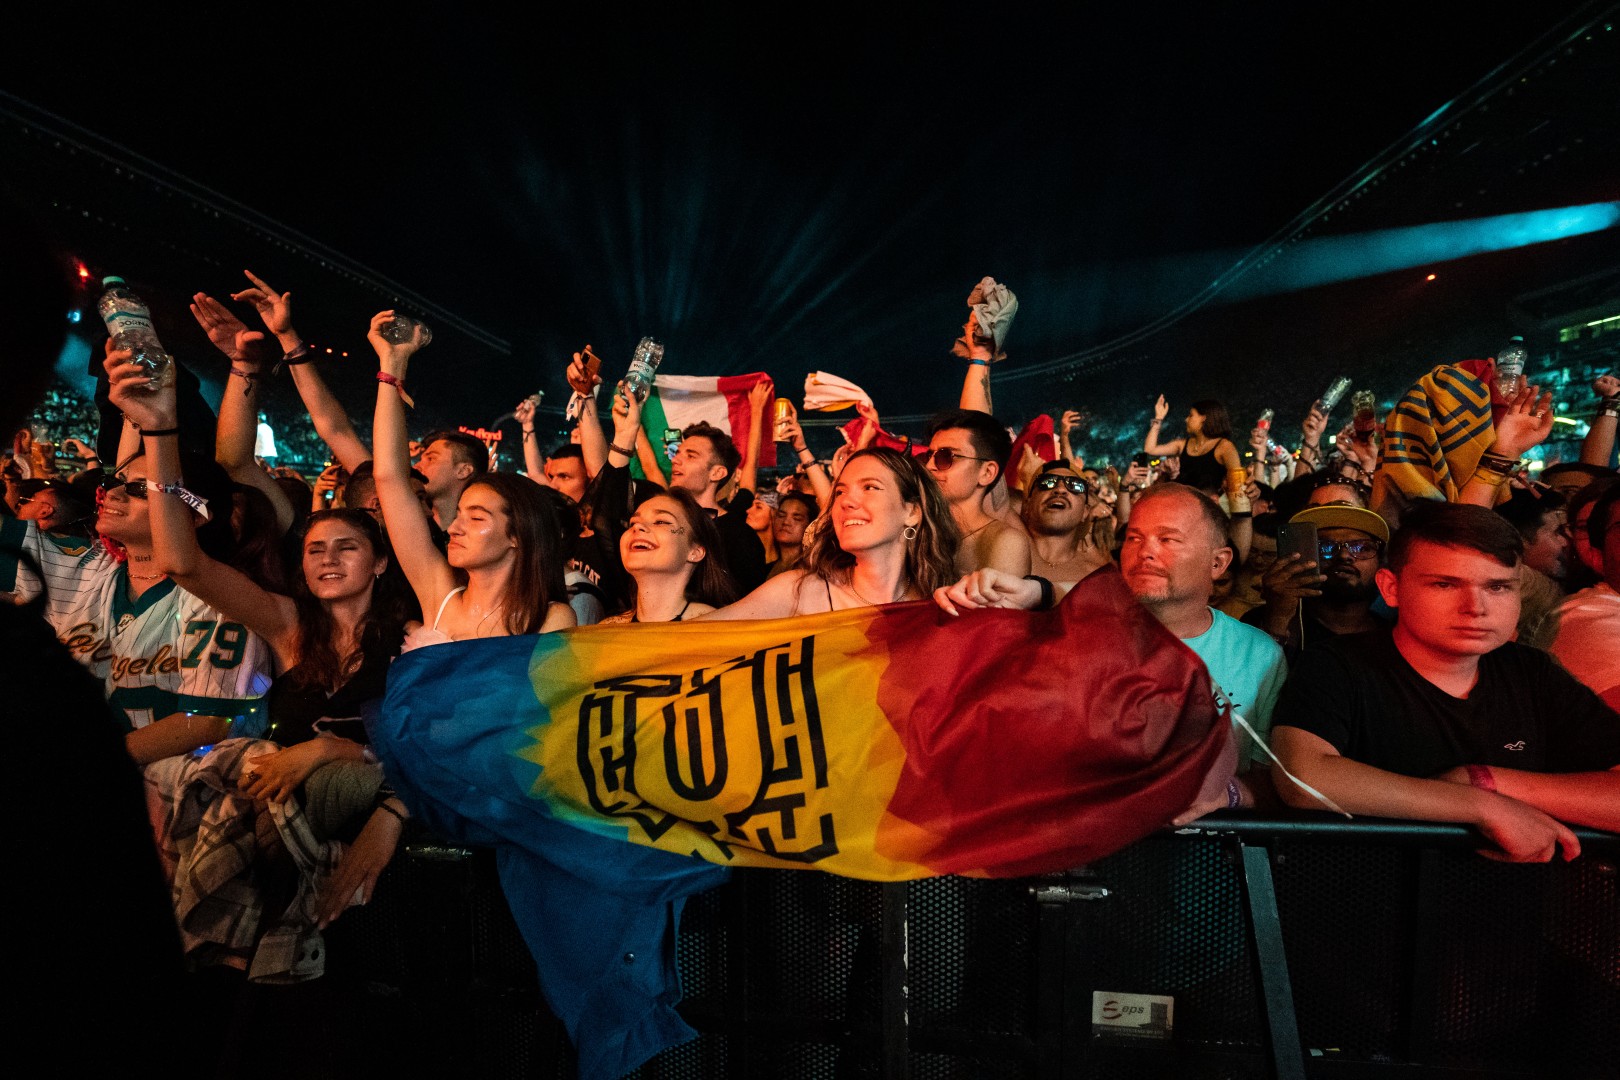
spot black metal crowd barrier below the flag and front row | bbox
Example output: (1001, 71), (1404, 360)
(301, 814), (1620, 1080)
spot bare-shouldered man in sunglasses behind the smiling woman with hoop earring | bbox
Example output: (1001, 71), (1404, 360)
(917, 408), (1030, 576)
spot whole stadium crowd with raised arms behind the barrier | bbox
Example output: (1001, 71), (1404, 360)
(9, 255), (1620, 1075)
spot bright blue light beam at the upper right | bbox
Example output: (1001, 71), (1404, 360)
(1221, 202), (1620, 303)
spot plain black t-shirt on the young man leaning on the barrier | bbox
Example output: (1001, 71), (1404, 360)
(1272, 630), (1620, 777)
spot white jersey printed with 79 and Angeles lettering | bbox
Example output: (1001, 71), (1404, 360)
(0, 521), (272, 738)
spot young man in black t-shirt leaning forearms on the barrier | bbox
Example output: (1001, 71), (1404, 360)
(1272, 504), (1620, 861)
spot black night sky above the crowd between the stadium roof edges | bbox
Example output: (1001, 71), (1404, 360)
(0, 3), (1614, 453)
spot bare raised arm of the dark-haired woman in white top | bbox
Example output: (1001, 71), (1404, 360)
(366, 311), (455, 612)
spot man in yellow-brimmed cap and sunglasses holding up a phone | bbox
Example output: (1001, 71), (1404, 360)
(1243, 504), (1390, 659)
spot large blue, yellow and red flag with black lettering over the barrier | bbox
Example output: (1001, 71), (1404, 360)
(373, 570), (1236, 1075)
